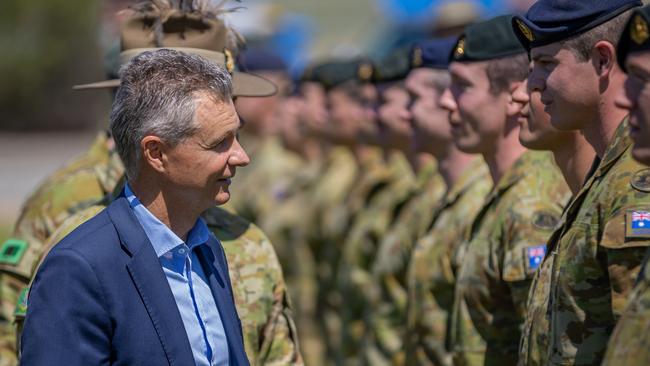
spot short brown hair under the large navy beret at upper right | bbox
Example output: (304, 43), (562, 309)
(561, 9), (634, 62)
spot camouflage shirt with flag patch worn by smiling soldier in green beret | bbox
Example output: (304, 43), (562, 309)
(451, 151), (570, 365)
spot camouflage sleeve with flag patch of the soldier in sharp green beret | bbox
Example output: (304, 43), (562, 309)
(502, 198), (562, 322)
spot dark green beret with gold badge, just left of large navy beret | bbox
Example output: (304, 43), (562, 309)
(450, 15), (526, 62)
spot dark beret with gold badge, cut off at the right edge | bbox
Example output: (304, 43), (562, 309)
(617, 5), (650, 70)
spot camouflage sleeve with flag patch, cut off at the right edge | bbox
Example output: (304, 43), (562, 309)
(598, 204), (650, 319)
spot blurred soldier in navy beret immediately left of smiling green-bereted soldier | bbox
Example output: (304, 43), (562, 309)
(394, 39), (490, 365)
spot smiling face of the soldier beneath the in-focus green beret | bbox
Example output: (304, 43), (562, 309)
(441, 62), (510, 154)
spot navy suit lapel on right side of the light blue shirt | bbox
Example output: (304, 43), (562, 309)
(198, 236), (249, 366)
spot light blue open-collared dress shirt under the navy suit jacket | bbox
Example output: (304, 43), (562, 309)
(124, 183), (229, 366)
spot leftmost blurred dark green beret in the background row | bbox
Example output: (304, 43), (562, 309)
(301, 59), (374, 90)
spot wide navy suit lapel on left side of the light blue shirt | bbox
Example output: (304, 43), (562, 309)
(108, 197), (194, 365)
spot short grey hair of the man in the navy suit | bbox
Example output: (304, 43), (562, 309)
(110, 49), (232, 179)
